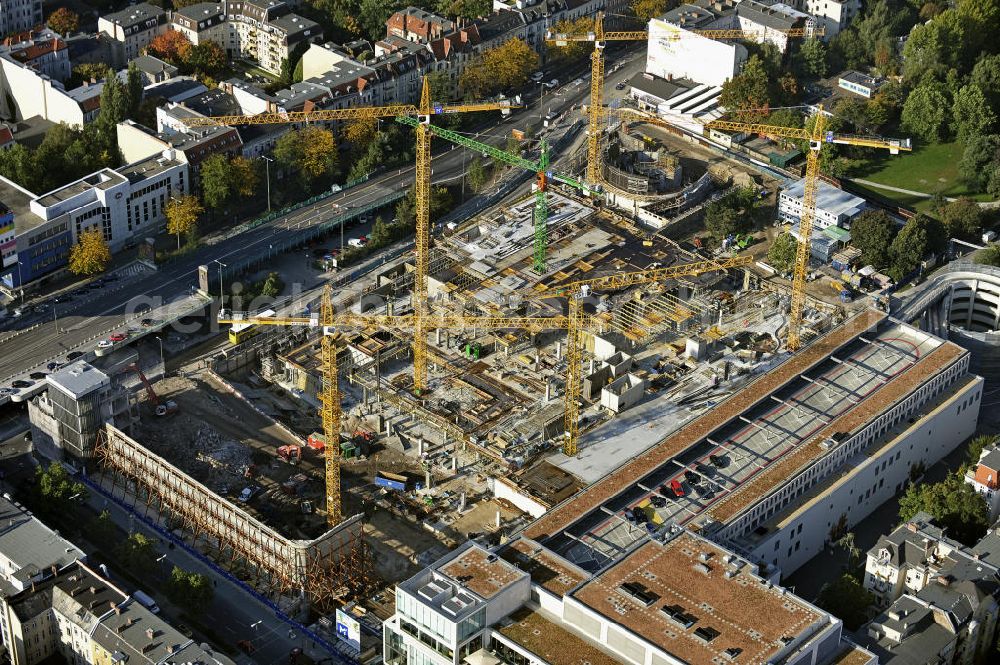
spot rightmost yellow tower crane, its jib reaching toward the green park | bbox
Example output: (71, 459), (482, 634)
(705, 106), (911, 351)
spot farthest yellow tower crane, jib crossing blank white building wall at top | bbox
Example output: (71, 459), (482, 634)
(545, 12), (823, 185)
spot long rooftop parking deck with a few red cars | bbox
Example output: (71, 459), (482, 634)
(557, 326), (937, 567)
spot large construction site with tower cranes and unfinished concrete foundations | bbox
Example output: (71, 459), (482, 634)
(58, 23), (916, 624)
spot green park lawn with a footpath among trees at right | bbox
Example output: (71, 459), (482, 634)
(851, 140), (992, 200)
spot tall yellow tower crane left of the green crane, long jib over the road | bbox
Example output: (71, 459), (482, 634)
(184, 77), (515, 394)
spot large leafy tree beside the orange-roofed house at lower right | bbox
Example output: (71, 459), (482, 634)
(899, 473), (989, 546)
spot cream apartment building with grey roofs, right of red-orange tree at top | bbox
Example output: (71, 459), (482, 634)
(171, 0), (323, 74)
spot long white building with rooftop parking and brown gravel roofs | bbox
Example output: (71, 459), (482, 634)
(384, 310), (982, 665)
